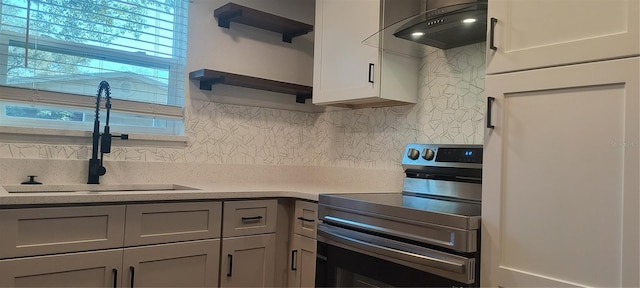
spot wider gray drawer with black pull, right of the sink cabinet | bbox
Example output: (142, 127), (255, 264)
(222, 200), (278, 237)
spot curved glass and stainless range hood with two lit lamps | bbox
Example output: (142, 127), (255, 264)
(363, 0), (487, 56)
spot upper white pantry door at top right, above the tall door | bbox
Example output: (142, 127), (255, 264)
(486, 0), (640, 74)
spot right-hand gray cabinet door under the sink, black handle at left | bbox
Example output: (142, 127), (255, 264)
(122, 239), (220, 287)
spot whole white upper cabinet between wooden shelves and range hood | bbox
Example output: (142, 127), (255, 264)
(313, 0), (418, 108)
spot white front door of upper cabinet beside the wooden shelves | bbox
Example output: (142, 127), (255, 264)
(313, 0), (380, 104)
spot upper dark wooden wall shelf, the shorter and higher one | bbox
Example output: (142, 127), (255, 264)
(213, 2), (313, 43)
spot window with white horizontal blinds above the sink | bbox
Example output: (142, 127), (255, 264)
(0, 0), (188, 135)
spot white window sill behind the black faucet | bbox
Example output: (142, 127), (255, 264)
(0, 126), (189, 148)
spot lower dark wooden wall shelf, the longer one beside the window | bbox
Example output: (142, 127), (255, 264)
(189, 69), (313, 103)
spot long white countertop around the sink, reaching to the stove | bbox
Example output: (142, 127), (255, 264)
(0, 159), (404, 206)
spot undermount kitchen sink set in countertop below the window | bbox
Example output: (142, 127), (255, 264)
(2, 184), (199, 193)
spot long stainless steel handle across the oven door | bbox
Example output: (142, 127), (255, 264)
(318, 224), (466, 274)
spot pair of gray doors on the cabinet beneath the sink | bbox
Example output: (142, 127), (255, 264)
(0, 239), (220, 287)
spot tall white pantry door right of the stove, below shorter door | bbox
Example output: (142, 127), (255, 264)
(480, 57), (640, 287)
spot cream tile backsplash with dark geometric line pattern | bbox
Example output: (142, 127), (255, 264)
(0, 43), (485, 170)
